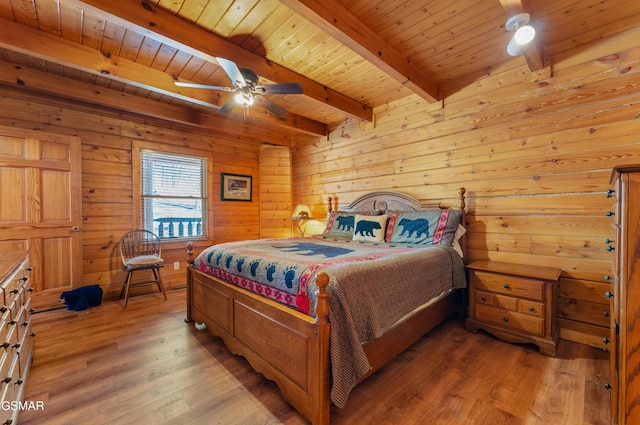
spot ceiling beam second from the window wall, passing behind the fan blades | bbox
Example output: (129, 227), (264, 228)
(0, 18), (328, 136)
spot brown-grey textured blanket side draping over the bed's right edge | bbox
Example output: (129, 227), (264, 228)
(308, 246), (466, 408)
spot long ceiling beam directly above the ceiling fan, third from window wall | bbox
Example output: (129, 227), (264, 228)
(64, 0), (373, 121)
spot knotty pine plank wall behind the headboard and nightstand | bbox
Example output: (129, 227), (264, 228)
(293, 48), (640, 347)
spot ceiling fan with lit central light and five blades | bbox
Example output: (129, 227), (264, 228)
(175, 58), (303, 118)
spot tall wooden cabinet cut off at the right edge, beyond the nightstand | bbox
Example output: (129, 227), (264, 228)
(606, 165), (640, 425)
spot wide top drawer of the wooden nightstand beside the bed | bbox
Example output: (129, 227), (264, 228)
(471, 270), (544, 301)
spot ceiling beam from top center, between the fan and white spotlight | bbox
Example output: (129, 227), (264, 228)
(280, 0), (441, 103)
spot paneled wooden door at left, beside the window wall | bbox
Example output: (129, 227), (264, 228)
(0, 127), (82, 310)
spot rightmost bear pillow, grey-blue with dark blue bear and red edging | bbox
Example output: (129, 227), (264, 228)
(385, 209), (462, 246)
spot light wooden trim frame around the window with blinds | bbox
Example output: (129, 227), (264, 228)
(131, 140), (213, 249)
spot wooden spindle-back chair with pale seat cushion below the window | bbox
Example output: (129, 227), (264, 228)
(118, 229), (167, 308)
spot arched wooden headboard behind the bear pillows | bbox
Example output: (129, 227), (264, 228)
(328, 187), (466, 213)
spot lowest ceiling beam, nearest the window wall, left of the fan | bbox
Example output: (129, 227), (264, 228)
(0, 61), (302, 146)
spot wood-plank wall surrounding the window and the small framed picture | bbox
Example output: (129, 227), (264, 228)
(0, 87), (260, 297)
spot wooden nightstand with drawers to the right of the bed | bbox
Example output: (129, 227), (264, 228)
(466, 261), (560, 356)
